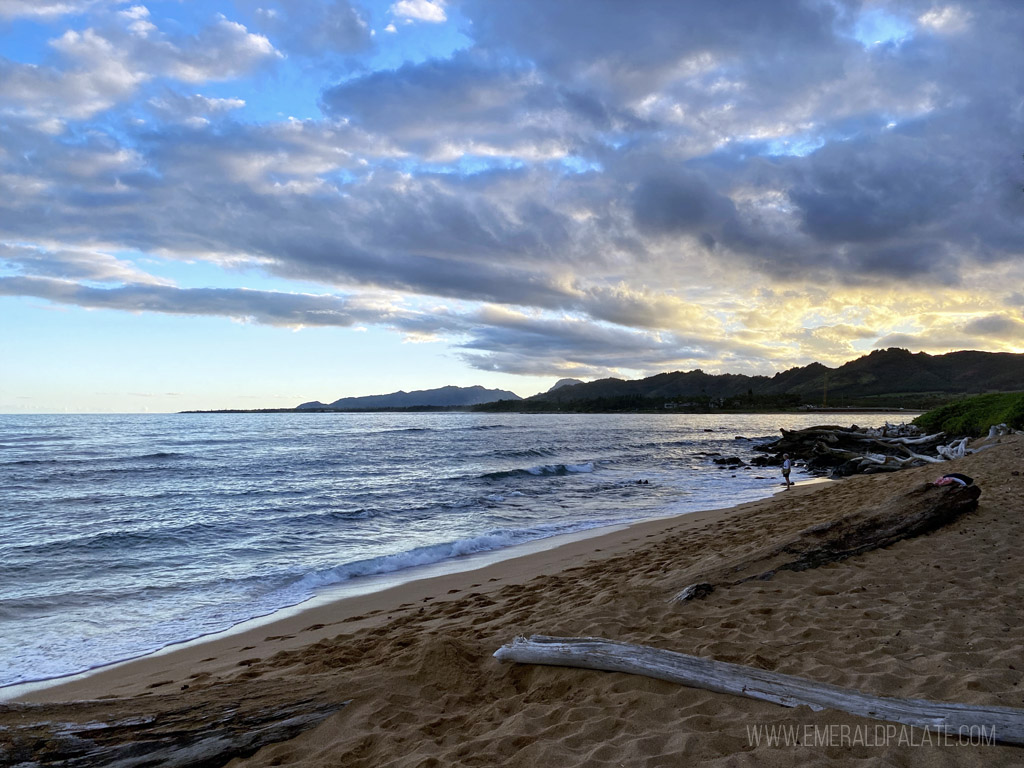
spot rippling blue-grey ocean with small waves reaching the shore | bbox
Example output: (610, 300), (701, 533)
(0, 414), (904, 686)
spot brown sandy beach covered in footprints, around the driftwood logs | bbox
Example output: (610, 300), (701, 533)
(0, 435), (1024, 768)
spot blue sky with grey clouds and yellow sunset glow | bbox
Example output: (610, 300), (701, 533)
(0, 0), (1024, 413)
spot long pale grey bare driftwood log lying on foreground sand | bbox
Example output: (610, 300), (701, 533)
(495, 635), (1024, 744)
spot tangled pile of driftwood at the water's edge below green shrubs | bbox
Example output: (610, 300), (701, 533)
(754, 424), (974, 476)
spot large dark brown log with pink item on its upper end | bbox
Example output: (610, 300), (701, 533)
(673, 483), (981, 601)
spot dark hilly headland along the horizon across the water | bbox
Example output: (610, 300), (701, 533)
(185, 348), (1024, 413)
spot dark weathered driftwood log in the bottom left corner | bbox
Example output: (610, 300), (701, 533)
(0, 697), (347, 768)
